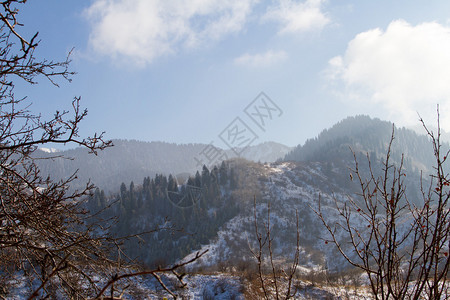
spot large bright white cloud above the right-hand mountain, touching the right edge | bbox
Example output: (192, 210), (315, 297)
(327, 20), (450, 130)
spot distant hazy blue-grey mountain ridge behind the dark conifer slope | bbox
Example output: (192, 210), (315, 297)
(35, 140), (291, 191)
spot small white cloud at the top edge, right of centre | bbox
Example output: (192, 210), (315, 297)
(263, 0), (330, 34)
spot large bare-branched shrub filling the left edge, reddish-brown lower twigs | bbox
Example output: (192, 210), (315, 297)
(0, 0), (201, 299)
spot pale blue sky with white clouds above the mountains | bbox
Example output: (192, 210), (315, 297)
(16, 0), (450, 148)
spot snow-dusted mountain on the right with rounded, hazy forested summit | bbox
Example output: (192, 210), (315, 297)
(182, 116), (440, 273)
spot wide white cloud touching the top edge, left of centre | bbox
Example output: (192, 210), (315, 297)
(85, 0), (258, 64)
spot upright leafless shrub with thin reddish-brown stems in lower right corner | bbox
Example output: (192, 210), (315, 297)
(316, 110), (450, 299)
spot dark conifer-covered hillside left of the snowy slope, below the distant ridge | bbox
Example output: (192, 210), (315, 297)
(88, 162), (240, 266)
